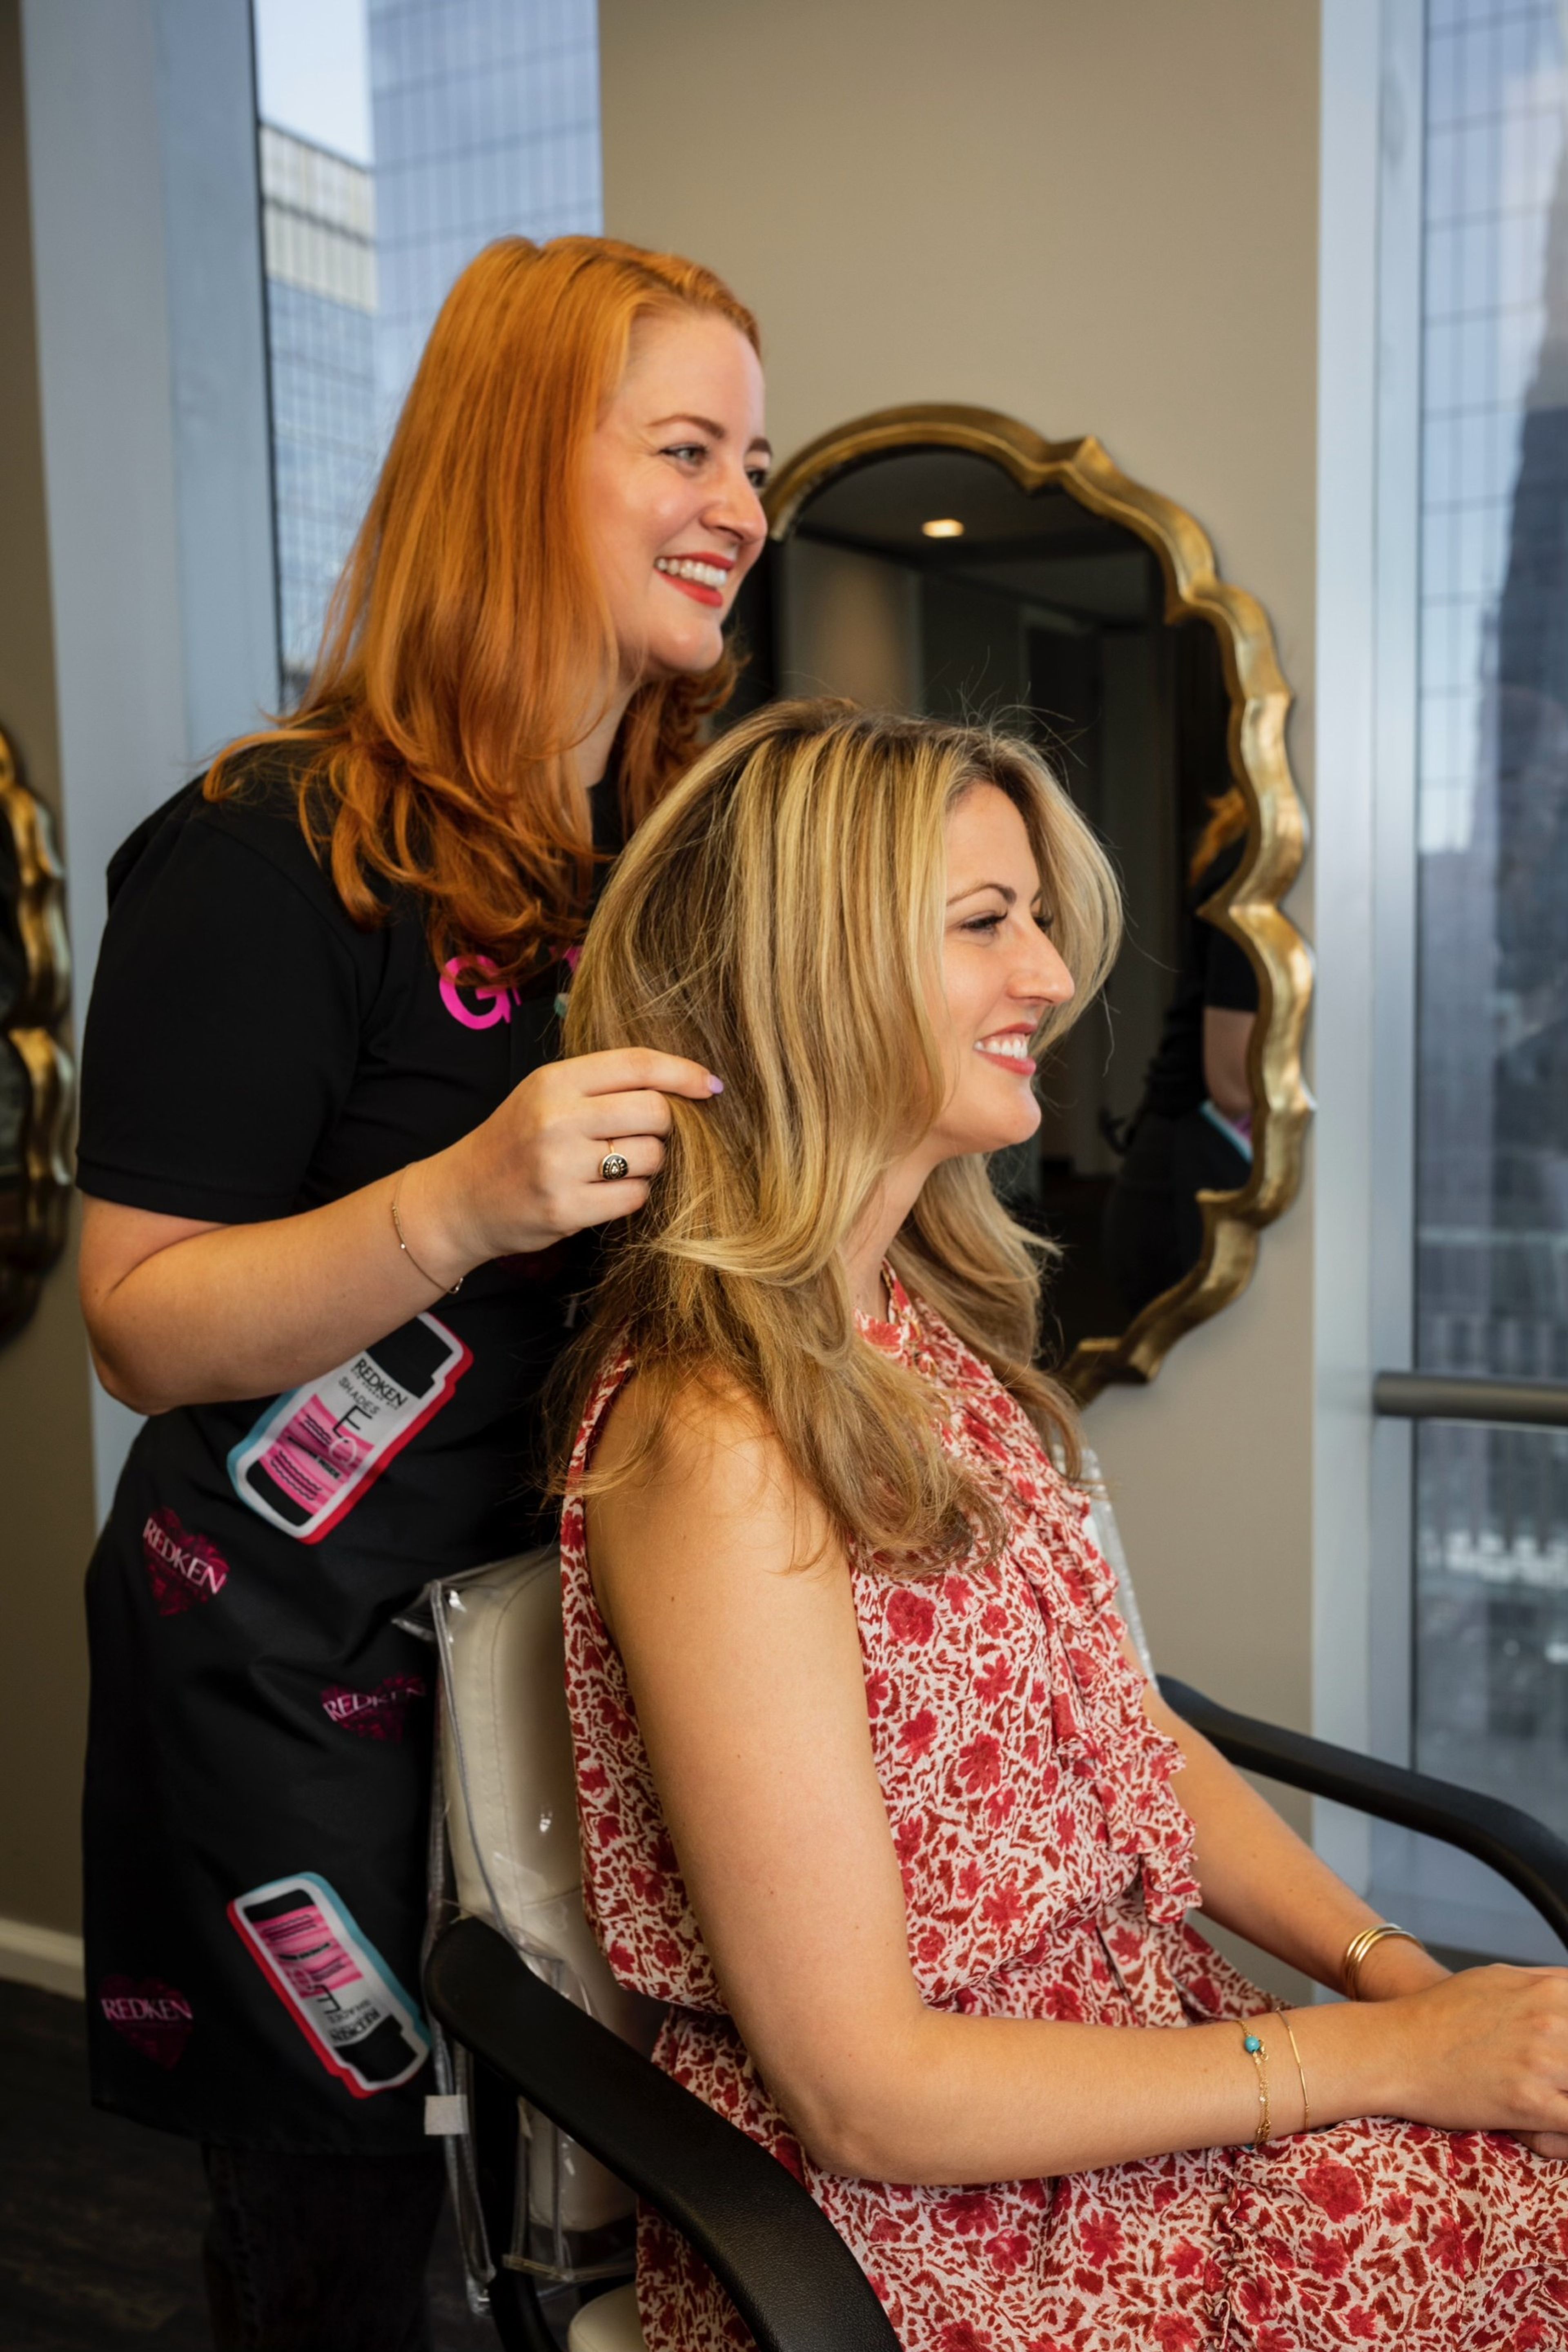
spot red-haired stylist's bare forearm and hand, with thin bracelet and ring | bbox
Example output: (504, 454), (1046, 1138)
(80, 1049), (715, 1414)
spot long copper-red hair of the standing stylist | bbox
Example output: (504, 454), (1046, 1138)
(205, 238), (762, 978)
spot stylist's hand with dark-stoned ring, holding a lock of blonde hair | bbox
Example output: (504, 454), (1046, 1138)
(400, 1047), (724, 1284)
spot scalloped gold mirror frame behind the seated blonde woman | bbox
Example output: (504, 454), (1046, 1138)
(766, 405), (1312, 1404)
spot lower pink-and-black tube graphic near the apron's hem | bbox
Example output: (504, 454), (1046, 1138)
(228, 1870), (430, 2098)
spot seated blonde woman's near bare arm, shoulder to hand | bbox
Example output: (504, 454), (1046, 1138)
(588, 1383), (1568, 2183)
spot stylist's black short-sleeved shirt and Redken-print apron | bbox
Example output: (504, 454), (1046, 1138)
(78, 757), (618, 2152)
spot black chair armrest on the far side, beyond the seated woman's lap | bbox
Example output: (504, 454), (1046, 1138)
(1159, 1675), (1568, 1945)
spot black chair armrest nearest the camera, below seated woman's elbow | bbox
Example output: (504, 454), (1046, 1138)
(425, 1919), (898, 2352)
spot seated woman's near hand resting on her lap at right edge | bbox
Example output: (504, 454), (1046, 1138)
(1382, 1966), (1568, 2157)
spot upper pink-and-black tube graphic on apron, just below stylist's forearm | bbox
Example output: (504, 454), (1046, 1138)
(228, 1315), (472, 1543)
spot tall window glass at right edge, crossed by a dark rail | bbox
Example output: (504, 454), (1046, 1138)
(1415, 0), (1568, 1950)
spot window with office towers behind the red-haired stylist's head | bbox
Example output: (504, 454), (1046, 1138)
(254, 0), (602, 706)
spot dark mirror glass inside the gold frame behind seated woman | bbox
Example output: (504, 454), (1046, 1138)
(745, 449), (1258, 1364)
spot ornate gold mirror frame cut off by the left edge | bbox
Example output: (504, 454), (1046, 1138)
(0, 715), (73, 1341)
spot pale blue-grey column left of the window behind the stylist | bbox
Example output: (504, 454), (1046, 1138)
(21, 0), (277, 1517)
